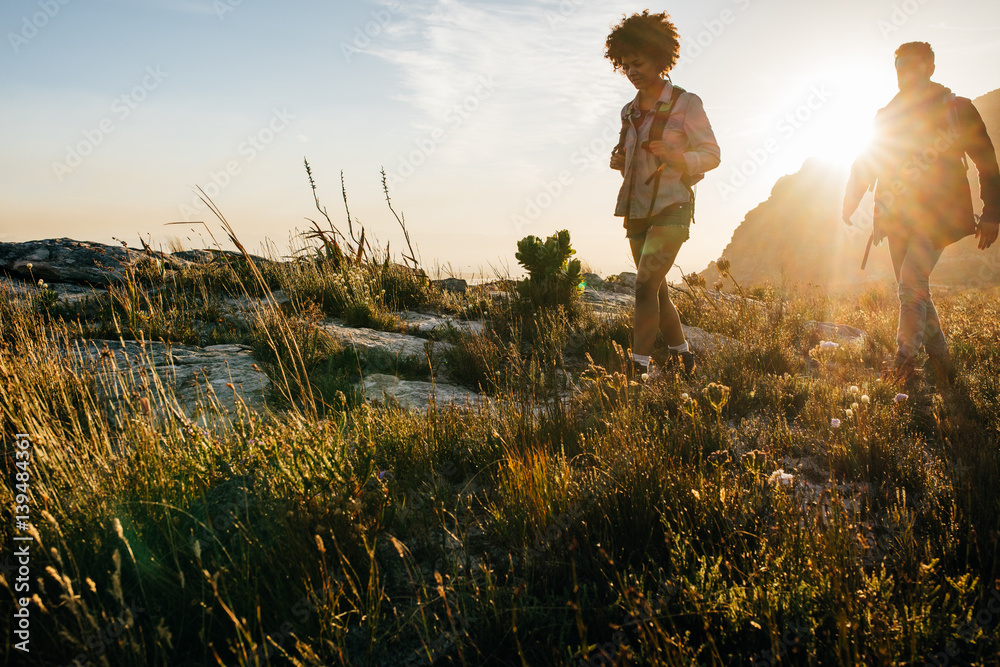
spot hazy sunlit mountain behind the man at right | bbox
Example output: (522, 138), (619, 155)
(702, 89), (1000, 287)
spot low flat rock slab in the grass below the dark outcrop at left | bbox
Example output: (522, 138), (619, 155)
(69, 340), (269, 418)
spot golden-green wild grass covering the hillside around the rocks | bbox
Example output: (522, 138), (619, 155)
(0, 222), (1000, 665)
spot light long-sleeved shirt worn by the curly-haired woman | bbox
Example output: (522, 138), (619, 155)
(615, 81), (720, 218)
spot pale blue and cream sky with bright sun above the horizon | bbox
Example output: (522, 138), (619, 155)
(0, 0), (1000, 278)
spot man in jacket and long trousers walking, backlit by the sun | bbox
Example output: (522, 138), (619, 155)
(843, 42), (1000, 384)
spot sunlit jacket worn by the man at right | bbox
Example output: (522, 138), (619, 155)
(845, 83), (1000, 247)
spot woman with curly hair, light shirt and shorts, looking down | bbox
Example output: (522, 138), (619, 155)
(605, 10), (720, 375)
